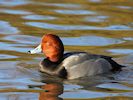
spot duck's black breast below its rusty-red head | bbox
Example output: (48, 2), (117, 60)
(40, 58), (67, 78)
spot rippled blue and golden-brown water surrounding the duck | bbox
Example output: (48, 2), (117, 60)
(0, 0), (133, 100)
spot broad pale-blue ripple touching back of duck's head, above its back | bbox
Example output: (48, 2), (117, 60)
(62, 36), (124, 46)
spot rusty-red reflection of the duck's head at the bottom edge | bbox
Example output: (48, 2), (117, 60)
(39, 83), (63, 100)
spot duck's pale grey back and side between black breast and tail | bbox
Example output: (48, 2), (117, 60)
(61, 52), (112, 79)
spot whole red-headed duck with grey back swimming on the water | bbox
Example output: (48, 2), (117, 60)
(28, 33), (124, 79)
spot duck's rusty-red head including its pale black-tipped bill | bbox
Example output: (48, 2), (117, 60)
(28, 34), (64, 62)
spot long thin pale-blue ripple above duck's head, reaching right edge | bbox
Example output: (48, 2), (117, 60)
(25, 22), (133, 30)
